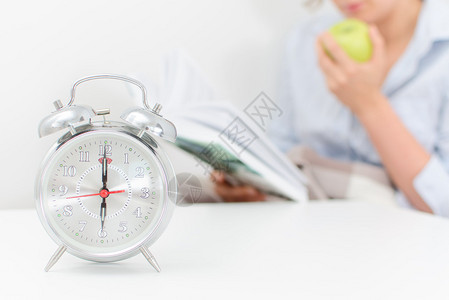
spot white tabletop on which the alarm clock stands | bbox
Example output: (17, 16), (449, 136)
(0, 202), (449, 299)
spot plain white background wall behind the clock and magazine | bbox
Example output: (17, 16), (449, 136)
(0, 0), (332, 208)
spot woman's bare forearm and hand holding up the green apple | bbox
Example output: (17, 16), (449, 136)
(316, 26), (432, 213)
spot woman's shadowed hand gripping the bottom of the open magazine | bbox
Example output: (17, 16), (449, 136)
(211, 172), (266, 202)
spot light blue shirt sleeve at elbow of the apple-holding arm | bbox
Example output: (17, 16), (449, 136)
(413, 91), (449, 217)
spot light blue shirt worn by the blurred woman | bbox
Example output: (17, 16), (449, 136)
(271, 0), (449, 217)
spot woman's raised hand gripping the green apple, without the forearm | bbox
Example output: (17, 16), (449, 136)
(316, 26), (387, 115)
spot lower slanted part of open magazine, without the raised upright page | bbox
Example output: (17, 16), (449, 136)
(167, 102), (307, 202)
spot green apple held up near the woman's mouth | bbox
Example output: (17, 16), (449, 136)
(329, 19), (373, 63)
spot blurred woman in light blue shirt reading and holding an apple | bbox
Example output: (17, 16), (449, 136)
(216, 0), (449, 216)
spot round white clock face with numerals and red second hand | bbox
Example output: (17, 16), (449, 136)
(38, 130), (169, 256)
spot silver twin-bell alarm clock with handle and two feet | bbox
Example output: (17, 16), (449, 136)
(35, 75), (177, 272)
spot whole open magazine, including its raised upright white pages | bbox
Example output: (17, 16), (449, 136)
(125, 49), (308, 202)
